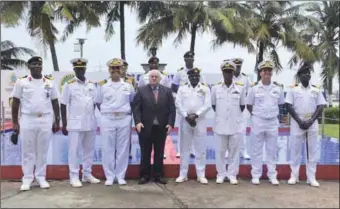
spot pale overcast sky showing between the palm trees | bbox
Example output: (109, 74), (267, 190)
(1, 5), (339, 89)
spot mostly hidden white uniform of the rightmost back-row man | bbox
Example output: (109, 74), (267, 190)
(233, 73), (250, 157)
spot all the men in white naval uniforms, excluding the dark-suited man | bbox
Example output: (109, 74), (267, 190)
(12, 52), (325, 191)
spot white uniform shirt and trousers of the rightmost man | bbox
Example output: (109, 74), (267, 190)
(286, 84), (326, 181)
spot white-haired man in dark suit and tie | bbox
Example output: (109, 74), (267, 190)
(133, 70), (176, 184)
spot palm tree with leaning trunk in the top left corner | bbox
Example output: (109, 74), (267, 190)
(1, 1), (105, 71)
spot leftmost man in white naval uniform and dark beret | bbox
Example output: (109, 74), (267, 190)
(12, 57), (60, 191)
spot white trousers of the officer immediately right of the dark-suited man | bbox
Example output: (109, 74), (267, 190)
(180, 118), (206, 177)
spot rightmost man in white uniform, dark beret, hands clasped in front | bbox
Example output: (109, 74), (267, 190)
(286, 63), (326, 187)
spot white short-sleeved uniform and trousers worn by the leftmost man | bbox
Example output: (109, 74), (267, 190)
(12, 75), (58, 184)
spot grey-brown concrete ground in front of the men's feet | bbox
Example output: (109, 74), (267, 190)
(1, 180), (339, 208)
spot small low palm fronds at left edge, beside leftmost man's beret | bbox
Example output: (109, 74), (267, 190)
(0, 40), (35, 70)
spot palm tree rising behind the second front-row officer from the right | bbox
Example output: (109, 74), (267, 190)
(248, 1), (315, 80)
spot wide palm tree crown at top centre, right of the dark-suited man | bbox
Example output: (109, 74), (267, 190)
(136, 2), (247, 51)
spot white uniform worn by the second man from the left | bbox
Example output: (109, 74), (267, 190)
(60, 78), (97, 181)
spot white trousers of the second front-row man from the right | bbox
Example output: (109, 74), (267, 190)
(251, 116), (278, 179)
